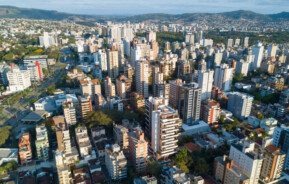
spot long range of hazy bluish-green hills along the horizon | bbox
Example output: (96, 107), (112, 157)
(0, 6), (289, 22)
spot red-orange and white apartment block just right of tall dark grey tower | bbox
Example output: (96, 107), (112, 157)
(201, 100), (221, 125)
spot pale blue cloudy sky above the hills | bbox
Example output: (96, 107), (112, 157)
(0, 0), (289, 15)
